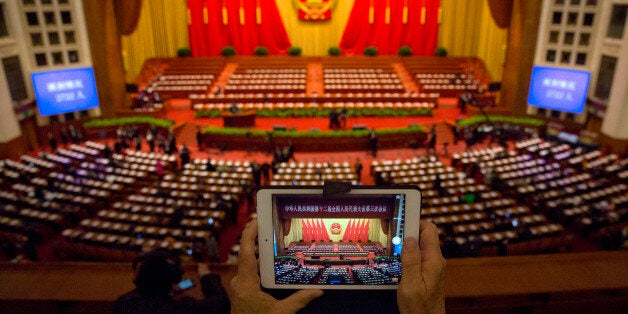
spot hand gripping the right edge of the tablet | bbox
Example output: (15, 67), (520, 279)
(397, 221), (445, 314)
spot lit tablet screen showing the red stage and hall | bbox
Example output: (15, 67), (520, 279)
(273, 194), (406, 285)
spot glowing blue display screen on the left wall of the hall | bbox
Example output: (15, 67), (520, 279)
(32, 68), (99, 116)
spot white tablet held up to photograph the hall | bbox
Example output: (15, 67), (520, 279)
(257, 186), (421, 289)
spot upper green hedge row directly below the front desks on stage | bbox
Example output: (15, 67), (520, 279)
(195, 108), (434, 118)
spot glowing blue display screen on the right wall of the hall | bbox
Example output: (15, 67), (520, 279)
(528, 66), (591, 113)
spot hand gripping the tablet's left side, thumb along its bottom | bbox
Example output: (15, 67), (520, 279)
(231, 219), (323, 313)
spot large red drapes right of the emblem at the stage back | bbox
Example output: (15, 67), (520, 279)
(340, 0), (440, 55)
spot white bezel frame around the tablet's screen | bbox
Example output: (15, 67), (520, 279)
(257, 186), (421, 290)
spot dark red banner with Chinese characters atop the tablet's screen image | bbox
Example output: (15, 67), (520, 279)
(275, 195), (396, 219)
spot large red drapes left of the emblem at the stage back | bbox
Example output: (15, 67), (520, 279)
(187, 0), (291, 56)
